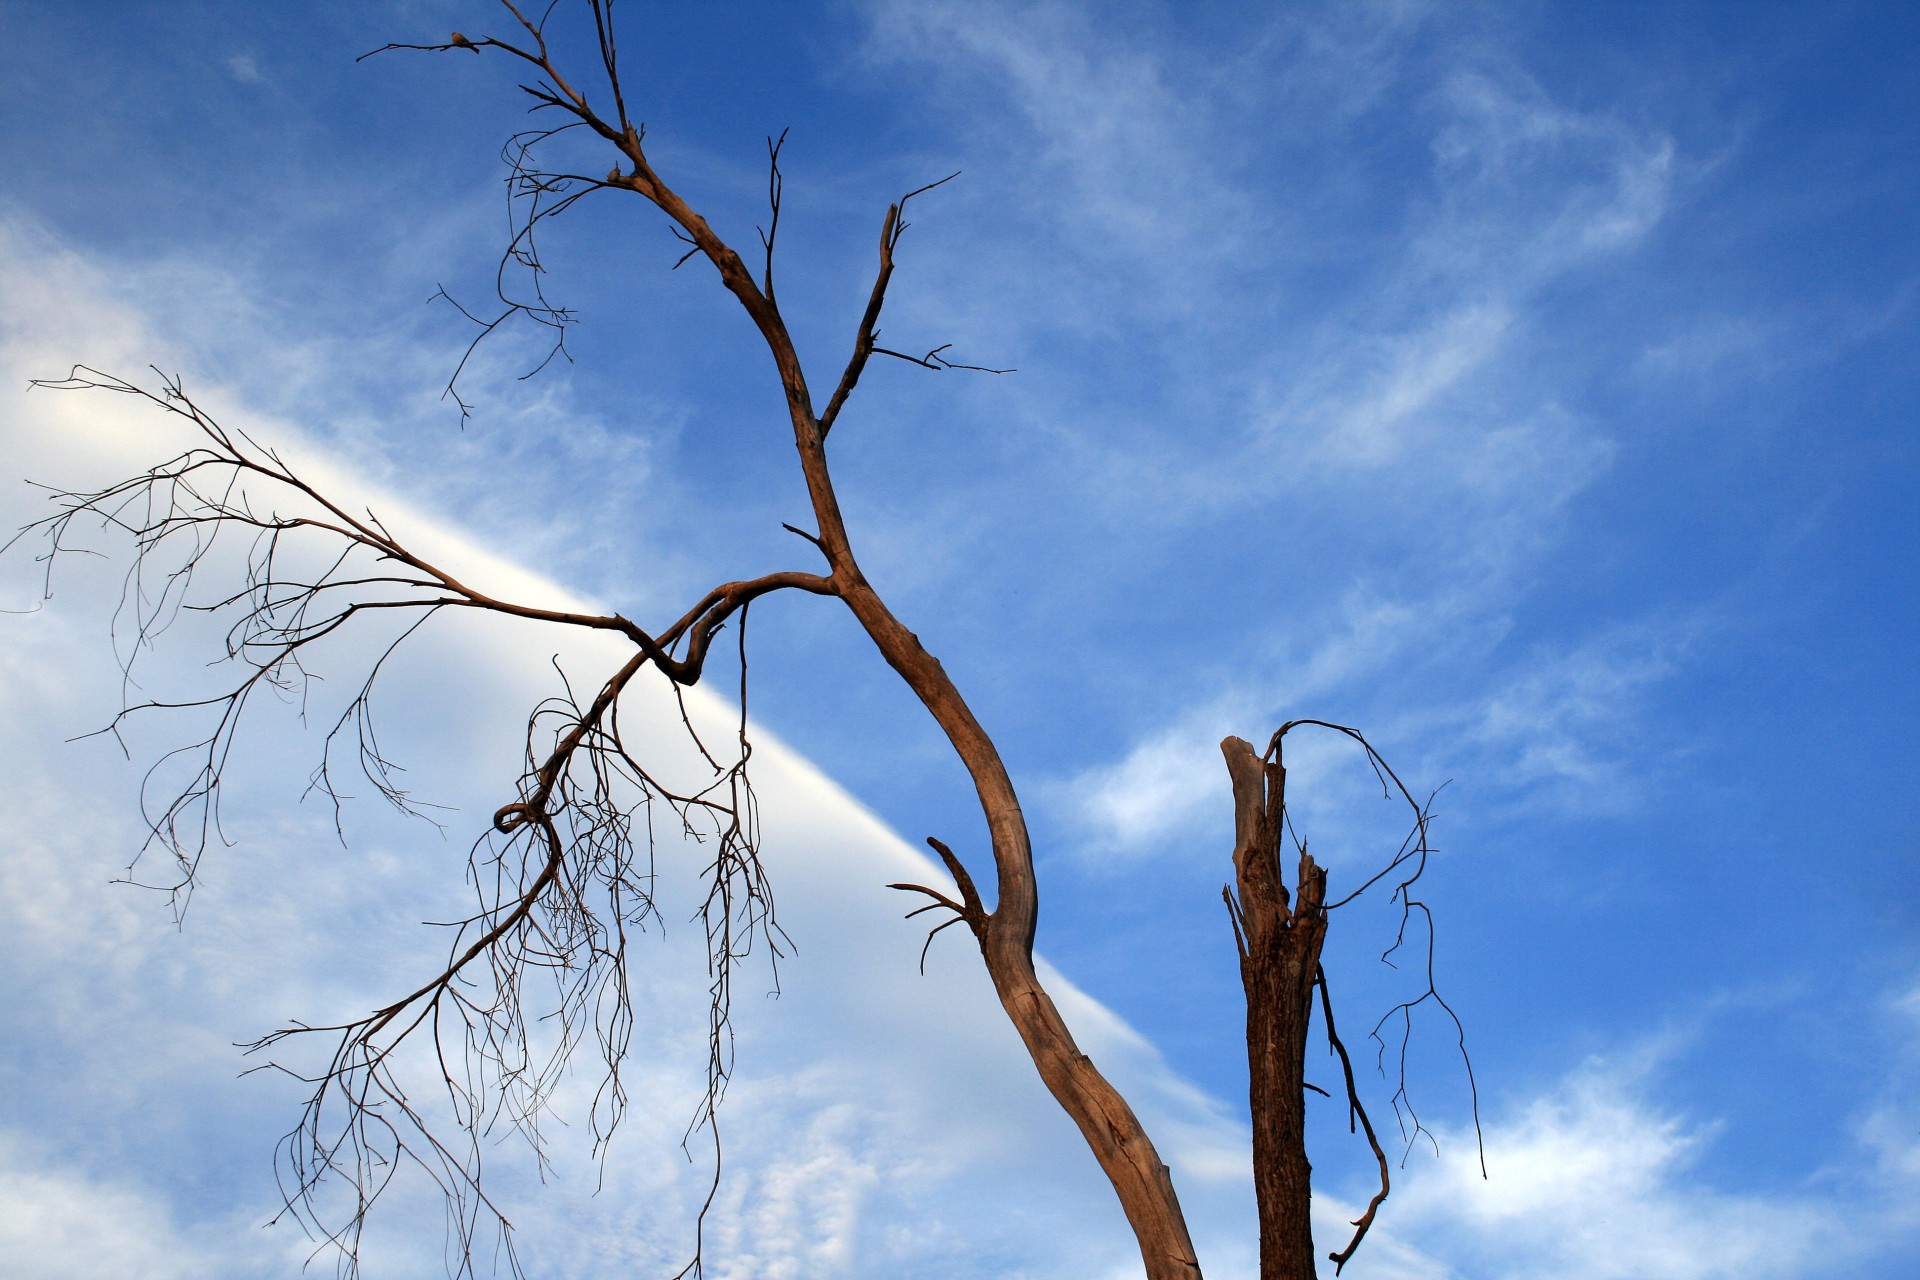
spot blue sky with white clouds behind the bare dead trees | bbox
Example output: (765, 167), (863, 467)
(0, 0), (1920, 1280)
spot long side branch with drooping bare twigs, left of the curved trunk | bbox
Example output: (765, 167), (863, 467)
(23, 367), (831, 1274)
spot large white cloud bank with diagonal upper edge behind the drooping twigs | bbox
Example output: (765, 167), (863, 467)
(0, 214), (1242, 1280)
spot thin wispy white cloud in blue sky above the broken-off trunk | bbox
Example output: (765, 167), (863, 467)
(1050, 27), (1676, 856)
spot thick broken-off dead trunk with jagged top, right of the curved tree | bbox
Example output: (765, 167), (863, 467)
(1219, 737), (1327, 1280)
